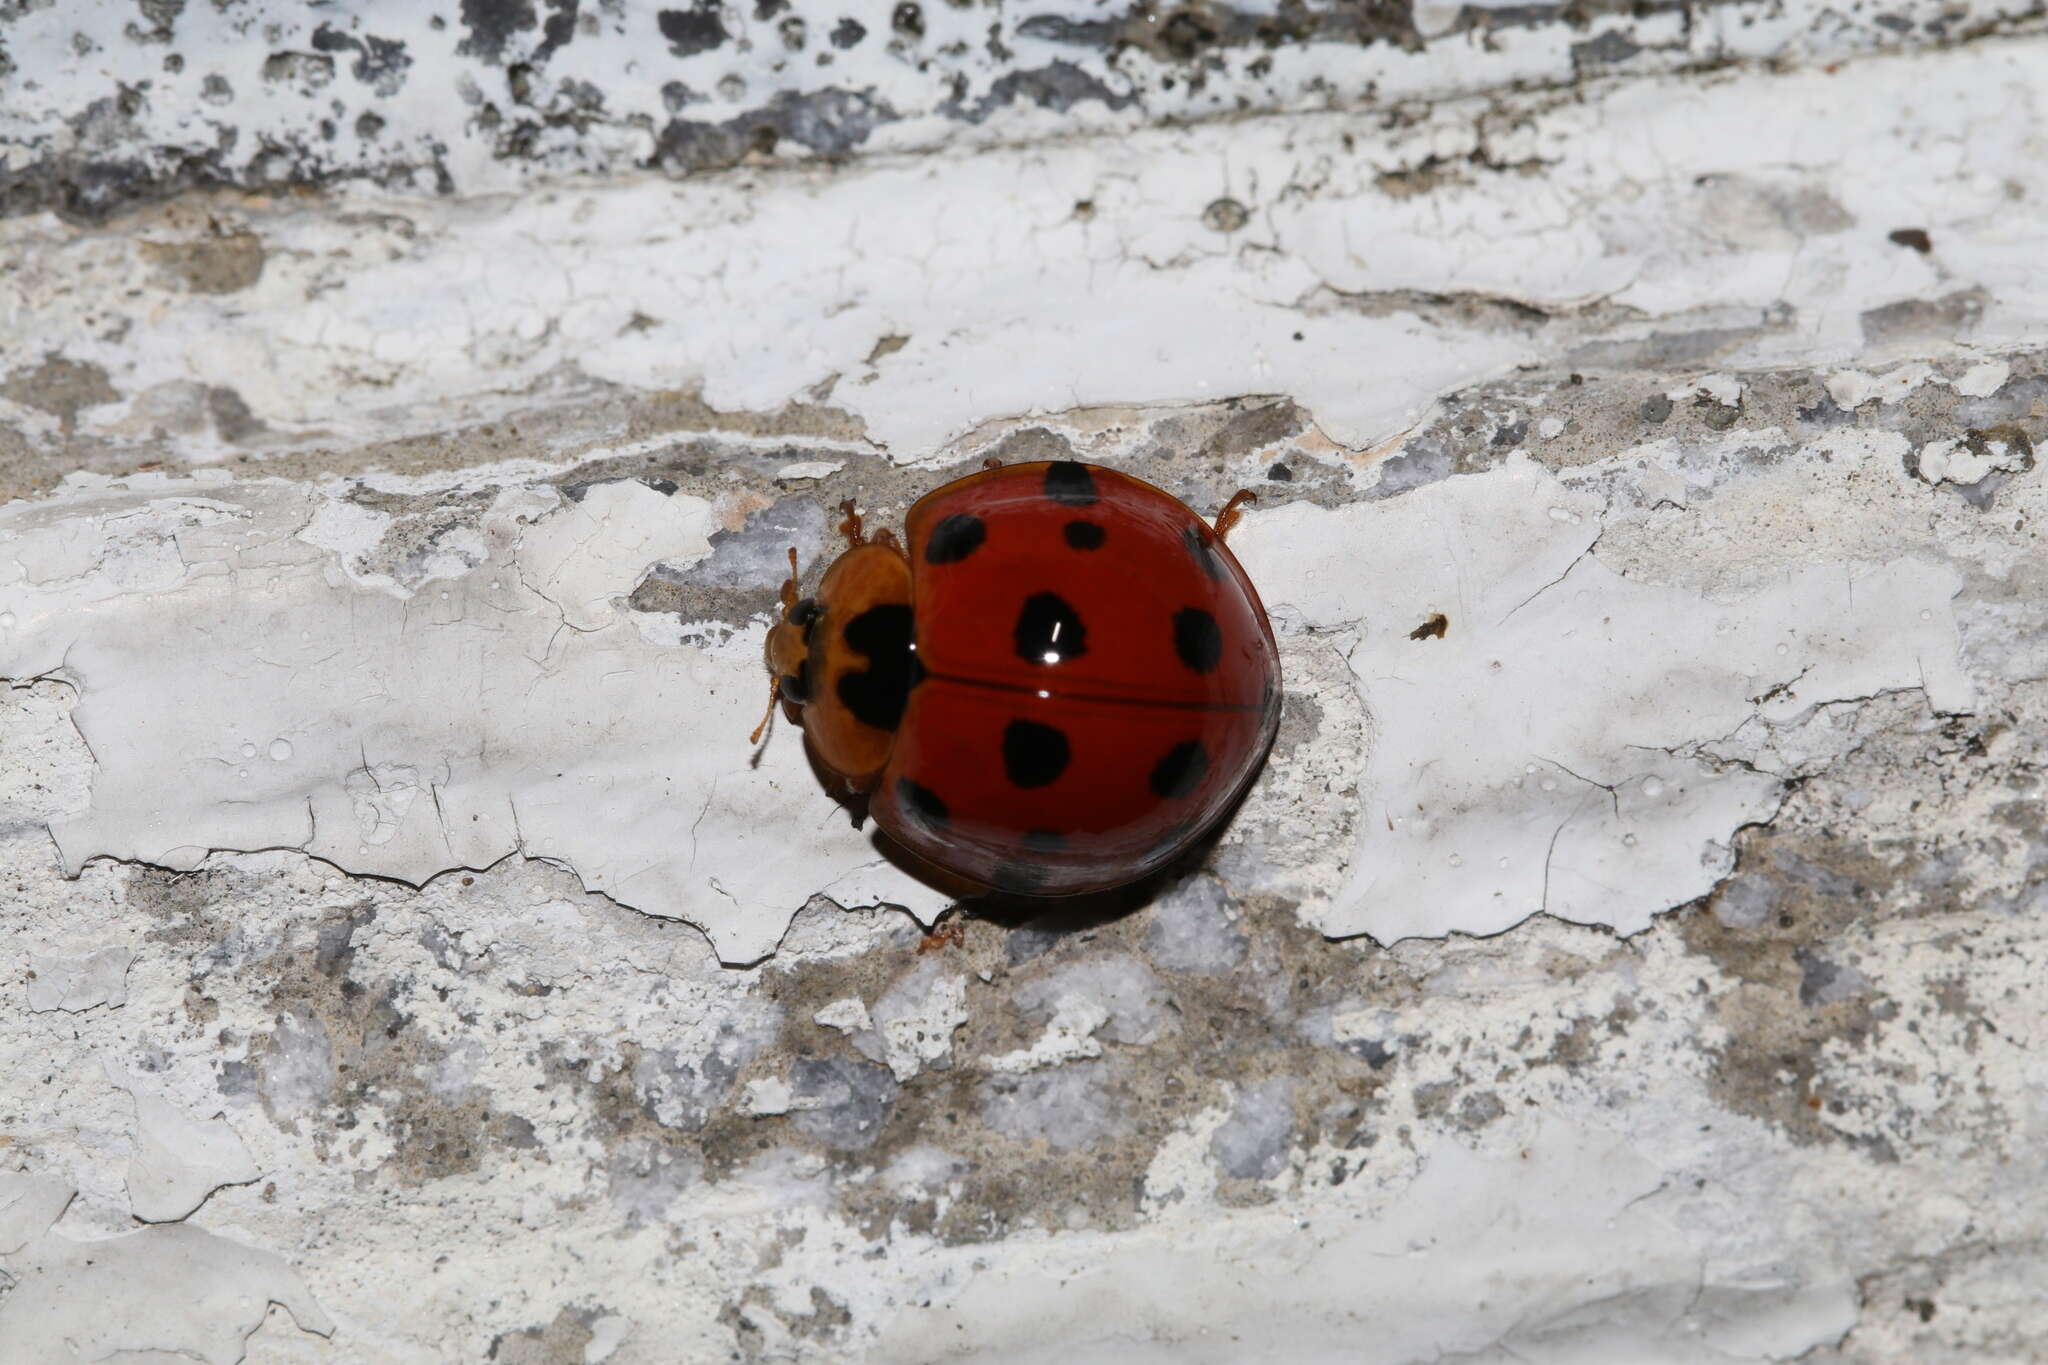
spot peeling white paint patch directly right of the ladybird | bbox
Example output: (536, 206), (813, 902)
(1235, 460), (1972, 941)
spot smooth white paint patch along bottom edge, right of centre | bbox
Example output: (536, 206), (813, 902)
(870, 1124), (1855, 1365)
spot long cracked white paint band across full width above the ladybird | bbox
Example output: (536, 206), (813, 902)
(0, 45), (2048, 472)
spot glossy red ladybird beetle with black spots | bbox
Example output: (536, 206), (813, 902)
(756, 460), (1280, 896)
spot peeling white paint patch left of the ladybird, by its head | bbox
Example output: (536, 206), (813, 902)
(0, 481), (944, 962)
